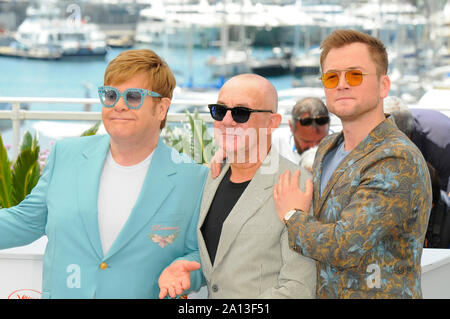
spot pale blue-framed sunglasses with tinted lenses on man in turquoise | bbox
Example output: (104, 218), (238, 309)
(98, 86), (162, 110)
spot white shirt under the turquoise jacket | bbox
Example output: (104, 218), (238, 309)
(98, 151), (153, 254)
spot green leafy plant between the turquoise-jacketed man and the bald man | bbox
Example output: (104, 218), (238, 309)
(162, 109), (217, 164)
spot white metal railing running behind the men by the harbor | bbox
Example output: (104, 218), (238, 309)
(0, 97), (340, 158)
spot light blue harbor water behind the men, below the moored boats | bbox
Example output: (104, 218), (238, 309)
(0, 45), (294, 102)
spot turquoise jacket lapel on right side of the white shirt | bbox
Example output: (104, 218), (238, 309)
(106, 139), (177, 258)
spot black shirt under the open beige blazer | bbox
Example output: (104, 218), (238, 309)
(201, 169), (250, 264)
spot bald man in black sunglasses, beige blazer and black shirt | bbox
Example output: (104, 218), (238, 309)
(158, 74), (316, 299)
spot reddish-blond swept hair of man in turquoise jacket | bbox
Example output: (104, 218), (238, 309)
(104, 49), (176, 129)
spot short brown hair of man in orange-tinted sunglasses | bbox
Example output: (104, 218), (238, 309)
(320, 30), (389, 76)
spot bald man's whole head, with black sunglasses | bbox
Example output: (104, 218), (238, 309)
(214, 74), (281, 168)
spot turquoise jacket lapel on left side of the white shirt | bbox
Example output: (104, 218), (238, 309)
(76, 135), (110, 258)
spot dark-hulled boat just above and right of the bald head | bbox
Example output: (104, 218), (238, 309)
(249, 47), (292, 76)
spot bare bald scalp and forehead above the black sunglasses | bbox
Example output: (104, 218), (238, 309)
(219, 73), (278, 113)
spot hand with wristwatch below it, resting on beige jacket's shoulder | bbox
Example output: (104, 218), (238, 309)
(273, 170), (313, 221)
